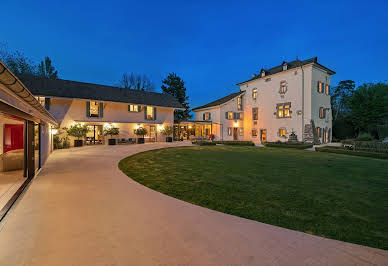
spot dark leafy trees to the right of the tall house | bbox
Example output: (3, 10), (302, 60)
(331, 80), (388, 140)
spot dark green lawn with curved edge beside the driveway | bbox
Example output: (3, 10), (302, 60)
(119, 146), (388, 249)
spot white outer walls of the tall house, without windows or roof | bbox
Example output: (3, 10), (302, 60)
(195, 64), (332, 142)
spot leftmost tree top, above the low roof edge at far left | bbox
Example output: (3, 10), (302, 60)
(0, 43), (36, 75)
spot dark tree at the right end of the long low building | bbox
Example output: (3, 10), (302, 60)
(161, 73), (192, 123)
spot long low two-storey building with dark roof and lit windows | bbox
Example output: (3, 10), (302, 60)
(20, 75), (182, 145)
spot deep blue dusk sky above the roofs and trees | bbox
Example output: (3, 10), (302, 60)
(0, 0), (388, 107)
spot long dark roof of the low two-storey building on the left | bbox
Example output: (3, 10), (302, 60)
(19, 75), (183, 108)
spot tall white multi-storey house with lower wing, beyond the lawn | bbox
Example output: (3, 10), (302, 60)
(193, 57), (335, 143)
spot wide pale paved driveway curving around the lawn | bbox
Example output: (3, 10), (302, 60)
(0, 143), (388, 266)
